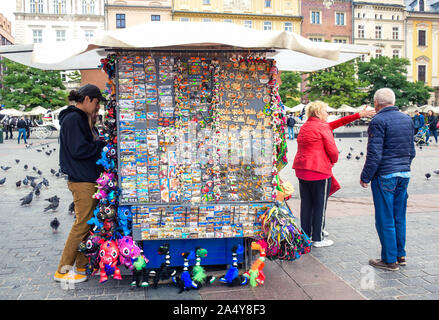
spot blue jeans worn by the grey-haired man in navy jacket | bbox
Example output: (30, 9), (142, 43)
(371, 177), (410, 263)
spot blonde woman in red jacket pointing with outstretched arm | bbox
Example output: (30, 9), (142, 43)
(293, 101), (373, 247)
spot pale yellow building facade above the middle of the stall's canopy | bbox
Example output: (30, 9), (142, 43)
(172, 0), (302, 34)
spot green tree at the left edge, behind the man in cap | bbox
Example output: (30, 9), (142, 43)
(0, 59), (67, 111)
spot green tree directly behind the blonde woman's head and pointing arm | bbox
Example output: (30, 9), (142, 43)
(305, 60), (369, 108)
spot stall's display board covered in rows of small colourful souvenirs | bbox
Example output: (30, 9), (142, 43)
(116, 53), (276, 240)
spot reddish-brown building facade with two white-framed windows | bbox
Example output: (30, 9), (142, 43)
(301, 0), (352, 43)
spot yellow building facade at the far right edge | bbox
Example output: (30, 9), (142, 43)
(406, 0), (439, 105)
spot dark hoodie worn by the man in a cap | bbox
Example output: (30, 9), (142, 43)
(59, 106), (106, 183)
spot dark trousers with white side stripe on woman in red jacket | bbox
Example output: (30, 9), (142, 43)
(299, 178), (331, 241)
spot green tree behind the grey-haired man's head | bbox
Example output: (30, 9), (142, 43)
(358, 56), (433, 107)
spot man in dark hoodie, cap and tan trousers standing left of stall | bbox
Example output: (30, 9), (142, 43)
(54, 84), (106, 283)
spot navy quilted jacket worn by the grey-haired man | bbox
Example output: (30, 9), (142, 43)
(361, 106), (416, 183)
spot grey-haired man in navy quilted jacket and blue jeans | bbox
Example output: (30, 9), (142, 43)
(360, 88), (415, 271)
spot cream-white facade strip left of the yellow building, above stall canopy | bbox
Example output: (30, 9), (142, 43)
(105, 0), (172, 30)
